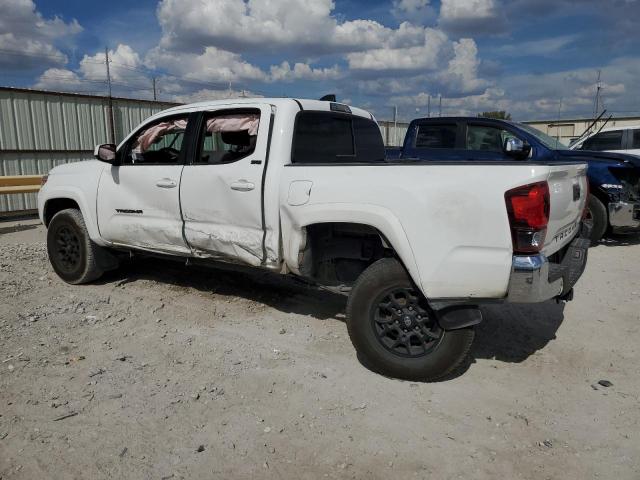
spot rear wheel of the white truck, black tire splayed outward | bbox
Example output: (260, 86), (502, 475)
(347, 258), (474, 382)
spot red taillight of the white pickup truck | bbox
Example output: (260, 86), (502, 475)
(504, 182), (550, 253)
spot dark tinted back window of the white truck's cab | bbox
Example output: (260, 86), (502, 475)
(292, 111), (384, 164)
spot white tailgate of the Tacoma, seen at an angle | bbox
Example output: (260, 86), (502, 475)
(542, 164), (588, 256)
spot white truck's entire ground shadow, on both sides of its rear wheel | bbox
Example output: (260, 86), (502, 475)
(96, 258), (564, 381)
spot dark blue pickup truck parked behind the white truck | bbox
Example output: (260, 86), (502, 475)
(387, 117), (640, 243)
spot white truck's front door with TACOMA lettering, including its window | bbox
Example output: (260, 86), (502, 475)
(97, 114), (190, 254)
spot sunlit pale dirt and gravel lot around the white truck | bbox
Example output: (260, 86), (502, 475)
(0, 221), (640, 480)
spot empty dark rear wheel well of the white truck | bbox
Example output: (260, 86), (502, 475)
(299, 222), (395, 286)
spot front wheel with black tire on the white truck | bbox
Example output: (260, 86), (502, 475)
(47, 208), (104, 285)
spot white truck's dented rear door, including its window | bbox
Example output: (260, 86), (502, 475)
(180, 104), (271, 266)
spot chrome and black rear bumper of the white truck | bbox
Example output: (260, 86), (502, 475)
(506, 232), (590, 303)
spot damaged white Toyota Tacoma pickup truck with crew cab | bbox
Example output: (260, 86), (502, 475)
(38, 98), (588, 381)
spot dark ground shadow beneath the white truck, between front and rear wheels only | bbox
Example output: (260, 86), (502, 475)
(95, 258), (347, 321)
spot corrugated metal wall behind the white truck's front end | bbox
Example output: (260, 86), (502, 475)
(0, 87), (175, 214)
